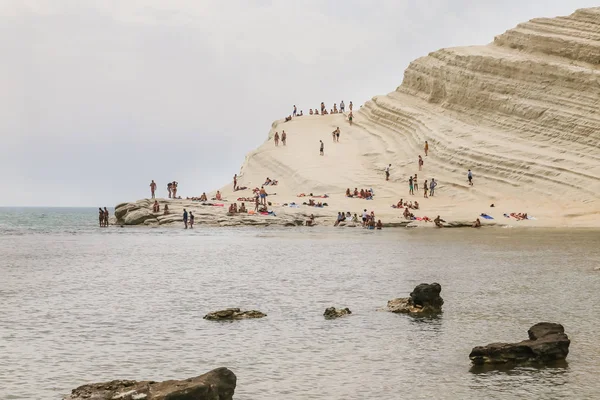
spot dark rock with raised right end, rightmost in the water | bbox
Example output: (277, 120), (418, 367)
(469, 322), (571, 365)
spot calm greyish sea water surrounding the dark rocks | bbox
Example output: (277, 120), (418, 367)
(0, 209), (600, 400)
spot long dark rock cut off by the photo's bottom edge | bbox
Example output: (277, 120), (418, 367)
(64, 368), (237, 400)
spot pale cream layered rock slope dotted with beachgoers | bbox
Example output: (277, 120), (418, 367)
(117, 8), (600, 227)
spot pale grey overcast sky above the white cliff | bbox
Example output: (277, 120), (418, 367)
(0, 0), (597, 206)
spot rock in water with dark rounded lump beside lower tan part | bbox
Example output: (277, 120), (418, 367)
(386, 283), (444, 314)
